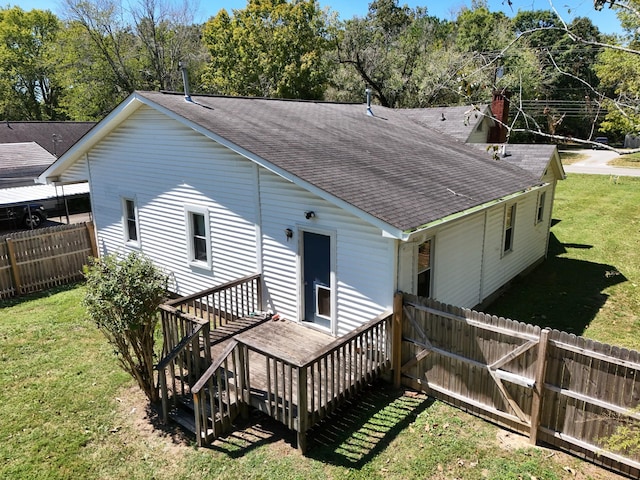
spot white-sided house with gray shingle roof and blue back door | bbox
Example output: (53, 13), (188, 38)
(39, 92), (564, 335)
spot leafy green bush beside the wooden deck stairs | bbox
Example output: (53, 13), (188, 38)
(83, 252), (168, 402)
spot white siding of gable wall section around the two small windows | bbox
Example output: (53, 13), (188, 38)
(88, 107), (258, 294)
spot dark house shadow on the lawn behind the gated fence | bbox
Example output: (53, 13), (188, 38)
(484, 233), (627, 335)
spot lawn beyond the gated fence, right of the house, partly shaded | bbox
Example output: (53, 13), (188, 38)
(486, 175), (640, 350)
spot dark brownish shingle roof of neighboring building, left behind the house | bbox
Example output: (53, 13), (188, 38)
(0, 121), (96, 157)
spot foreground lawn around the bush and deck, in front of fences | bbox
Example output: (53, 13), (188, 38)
(0, 286), (611, 480)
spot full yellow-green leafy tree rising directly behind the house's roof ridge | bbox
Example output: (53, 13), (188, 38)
(202, 0), (328, 99)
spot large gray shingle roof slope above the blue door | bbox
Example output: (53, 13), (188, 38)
(137, 92), (548, 231)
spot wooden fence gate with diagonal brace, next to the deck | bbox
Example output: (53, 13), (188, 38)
(401, 296), (541, 435)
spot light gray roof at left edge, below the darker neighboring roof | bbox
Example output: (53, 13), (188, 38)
(0, 142), (56, 188)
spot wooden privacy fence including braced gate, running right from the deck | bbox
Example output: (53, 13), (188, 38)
(394, 294), (640, 477)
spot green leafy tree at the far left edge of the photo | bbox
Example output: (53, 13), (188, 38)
(0, 7), (62, 120)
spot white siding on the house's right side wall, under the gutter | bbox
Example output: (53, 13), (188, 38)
(398, 186), (552, 308)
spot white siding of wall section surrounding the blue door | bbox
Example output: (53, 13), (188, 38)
(260, 169), (395, 335)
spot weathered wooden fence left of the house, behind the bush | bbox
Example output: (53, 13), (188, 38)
(0, 222), (98, 299)
